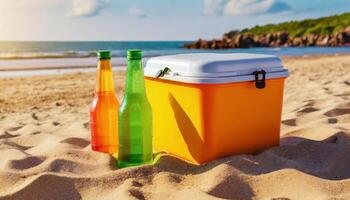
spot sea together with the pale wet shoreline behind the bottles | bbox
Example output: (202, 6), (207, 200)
(0, 41), (350, 77)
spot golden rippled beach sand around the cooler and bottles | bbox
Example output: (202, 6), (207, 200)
(0, 55), (350, 200)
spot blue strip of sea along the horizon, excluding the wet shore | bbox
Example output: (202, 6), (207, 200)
(0, 41), (350, 60)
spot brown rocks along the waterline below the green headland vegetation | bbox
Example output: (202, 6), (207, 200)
(185, 27), (350, 49)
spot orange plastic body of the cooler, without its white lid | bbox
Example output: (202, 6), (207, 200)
(146, 78), (284, 164)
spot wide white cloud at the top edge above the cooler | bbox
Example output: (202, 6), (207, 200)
(203, 0), (291, 16)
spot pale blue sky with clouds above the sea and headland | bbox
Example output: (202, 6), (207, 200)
(0, 0), (350, 41)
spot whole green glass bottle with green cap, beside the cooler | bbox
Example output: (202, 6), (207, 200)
(118, 50), (153, 168)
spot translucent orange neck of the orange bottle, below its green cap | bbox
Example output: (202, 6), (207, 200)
(96, 60), (114, 92)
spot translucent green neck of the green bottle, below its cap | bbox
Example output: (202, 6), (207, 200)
(125, 59), (145, 95)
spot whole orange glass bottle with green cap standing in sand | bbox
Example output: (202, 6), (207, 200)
(90, 51), (120, 154)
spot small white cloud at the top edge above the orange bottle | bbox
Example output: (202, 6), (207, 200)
(68, 0), (110, 17)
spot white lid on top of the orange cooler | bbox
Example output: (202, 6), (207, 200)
(145, 53), (288, 83)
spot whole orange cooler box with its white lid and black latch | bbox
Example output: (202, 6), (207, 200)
(145, 53), (288, 164)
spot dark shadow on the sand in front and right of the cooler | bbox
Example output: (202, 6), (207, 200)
(157, 132), (350, 199)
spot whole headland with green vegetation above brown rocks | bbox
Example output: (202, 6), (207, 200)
(185, 13), (350, 49)
